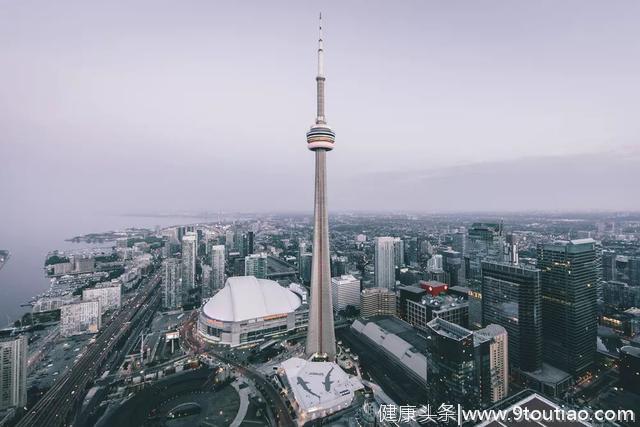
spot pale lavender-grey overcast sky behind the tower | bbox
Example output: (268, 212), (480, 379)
(0, 0), (640, 220)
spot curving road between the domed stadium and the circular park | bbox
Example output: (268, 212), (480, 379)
(180, 310), (296, 427)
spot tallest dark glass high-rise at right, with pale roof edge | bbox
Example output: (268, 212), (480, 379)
(538, 239), (598, 375)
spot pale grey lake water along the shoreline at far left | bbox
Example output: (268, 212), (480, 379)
(0, 215), (206, 327)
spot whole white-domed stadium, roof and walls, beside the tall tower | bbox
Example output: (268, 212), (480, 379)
(198, 276), (309, 347)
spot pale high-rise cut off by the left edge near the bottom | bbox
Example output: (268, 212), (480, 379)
(0, 335), (28, 411)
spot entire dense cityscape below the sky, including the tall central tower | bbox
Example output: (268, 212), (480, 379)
(0, 3), (640, 427)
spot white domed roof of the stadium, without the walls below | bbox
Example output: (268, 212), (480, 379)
(202, 276), (301, 322)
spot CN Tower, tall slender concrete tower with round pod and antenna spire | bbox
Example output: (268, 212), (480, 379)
(306, 15), (336, 361)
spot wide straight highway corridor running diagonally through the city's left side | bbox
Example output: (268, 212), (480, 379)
(17, 273), (160, 427)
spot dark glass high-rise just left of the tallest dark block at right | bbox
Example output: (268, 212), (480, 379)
(482, 261), (542, 371)
